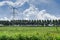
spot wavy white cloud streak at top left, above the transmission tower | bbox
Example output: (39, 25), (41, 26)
(0, 0), (27, 7)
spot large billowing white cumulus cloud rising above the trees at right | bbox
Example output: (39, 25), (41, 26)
(23, 6), (60, 20)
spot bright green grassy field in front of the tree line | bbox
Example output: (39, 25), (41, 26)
(0, 26), (60, 40)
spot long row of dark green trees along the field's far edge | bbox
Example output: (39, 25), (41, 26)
(0, 20), (60, 26)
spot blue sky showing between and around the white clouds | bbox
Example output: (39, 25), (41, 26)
(0, 0), (60, 19)
